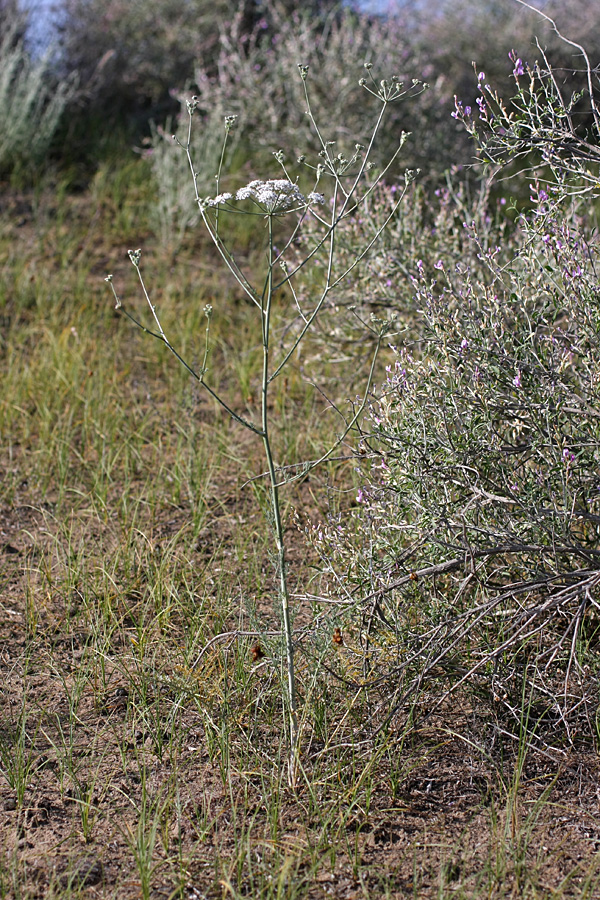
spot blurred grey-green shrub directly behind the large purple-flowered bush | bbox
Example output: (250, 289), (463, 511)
(288, 171), (514, 340)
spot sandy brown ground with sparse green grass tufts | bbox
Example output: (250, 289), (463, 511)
(0, 176), (600, 900)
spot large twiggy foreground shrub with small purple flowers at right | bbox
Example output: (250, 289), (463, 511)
(309, 33), (600, 743)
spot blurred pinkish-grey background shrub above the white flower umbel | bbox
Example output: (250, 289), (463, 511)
(188, 4), (458, 178)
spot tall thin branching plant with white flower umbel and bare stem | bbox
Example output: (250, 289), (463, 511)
(107, 64), (423, 782)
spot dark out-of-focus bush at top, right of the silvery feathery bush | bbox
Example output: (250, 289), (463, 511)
(56, 0), (344, 129)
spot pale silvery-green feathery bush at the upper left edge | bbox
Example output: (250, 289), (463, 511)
(0, 28), (75, 172)
